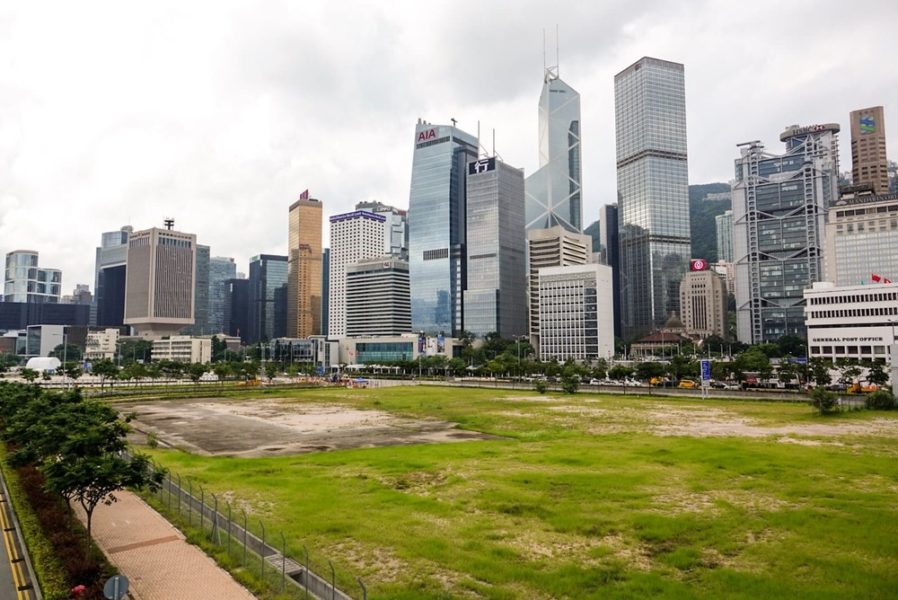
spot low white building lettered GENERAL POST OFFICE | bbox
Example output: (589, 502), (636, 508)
(804, 281), (898, 364)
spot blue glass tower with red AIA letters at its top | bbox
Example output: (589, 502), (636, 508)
(408, 119), (478, 337)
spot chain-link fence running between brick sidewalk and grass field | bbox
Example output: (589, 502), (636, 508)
(149, 464), (367, 600)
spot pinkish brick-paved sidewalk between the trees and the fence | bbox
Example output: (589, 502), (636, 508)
(76, 491), (255, 600)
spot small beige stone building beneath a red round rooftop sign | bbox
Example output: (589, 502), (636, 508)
(680, 271), (727, 338)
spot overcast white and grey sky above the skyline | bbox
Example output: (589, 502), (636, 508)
(0, 0), (898, 293)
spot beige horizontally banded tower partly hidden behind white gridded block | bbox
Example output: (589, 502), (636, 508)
(527, 225), (592, 351)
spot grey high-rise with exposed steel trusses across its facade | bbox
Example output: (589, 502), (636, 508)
(733, 123), (839, 344)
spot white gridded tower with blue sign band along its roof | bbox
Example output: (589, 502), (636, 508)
(327, 210), (387, 338)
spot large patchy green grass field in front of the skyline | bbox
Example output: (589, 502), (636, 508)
(142, 387), (898, 599)
